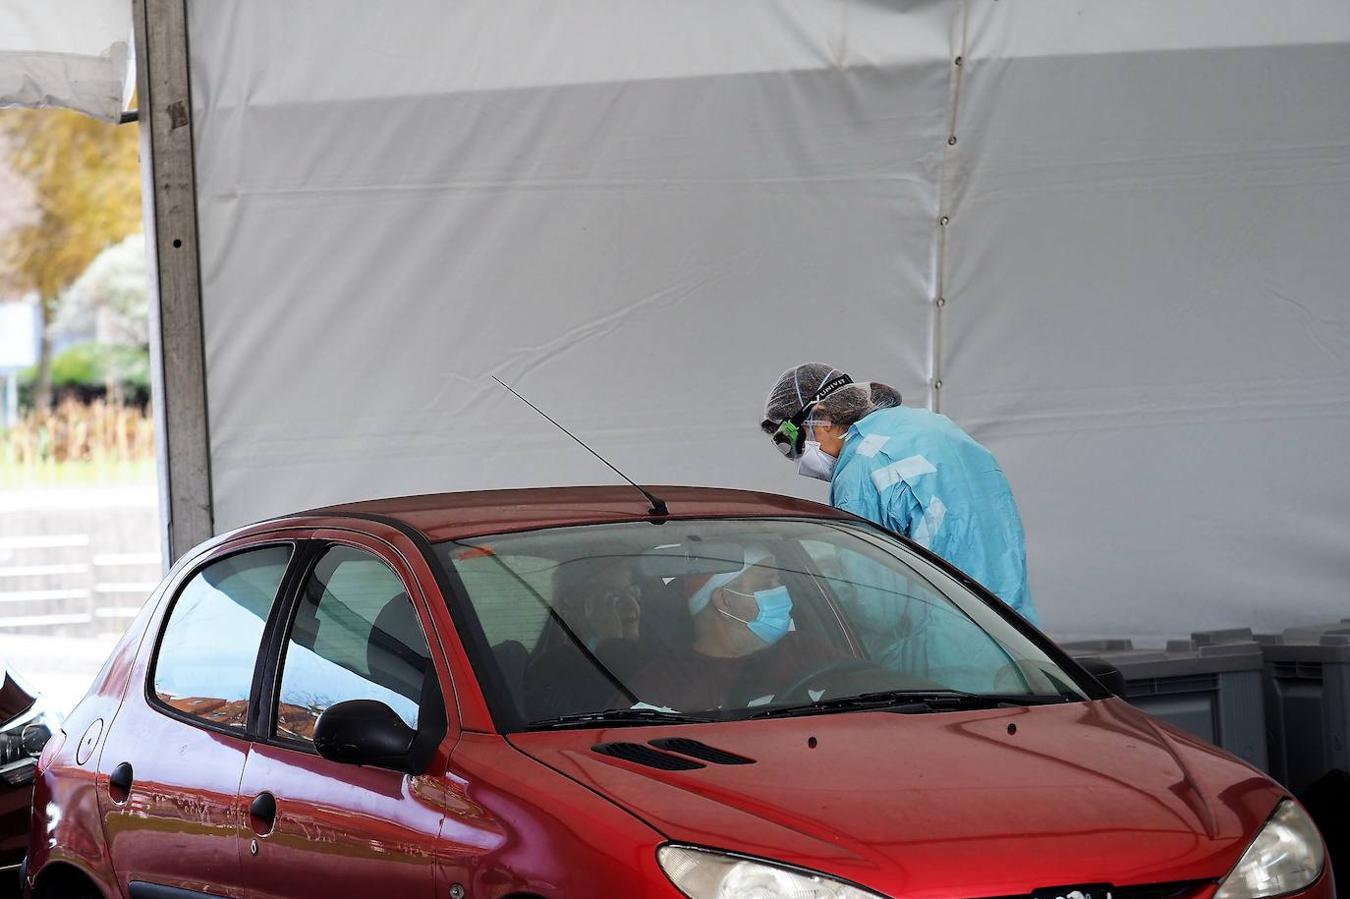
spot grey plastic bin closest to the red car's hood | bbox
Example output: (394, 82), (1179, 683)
(1061, 628), (1266, 771)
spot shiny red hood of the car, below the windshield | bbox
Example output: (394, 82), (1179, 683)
(510, 699), (1284, 899)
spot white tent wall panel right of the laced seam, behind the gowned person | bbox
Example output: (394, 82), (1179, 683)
(942, 0), (1350, 643)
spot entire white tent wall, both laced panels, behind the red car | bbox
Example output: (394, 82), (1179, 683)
(189, 0), (1350, 638)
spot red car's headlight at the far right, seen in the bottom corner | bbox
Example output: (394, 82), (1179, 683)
(1214, 800), (1326, 899)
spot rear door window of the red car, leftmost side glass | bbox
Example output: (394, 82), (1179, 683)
(154, 547), (290, 730)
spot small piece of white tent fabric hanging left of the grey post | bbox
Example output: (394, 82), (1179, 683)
(0, 0), (131, 121)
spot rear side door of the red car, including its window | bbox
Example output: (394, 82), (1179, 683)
(97, 544), (294, 899)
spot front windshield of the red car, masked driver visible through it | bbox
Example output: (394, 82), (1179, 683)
(436, 518), (1088, 730)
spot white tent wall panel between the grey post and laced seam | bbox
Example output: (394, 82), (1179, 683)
(189, 0), (953, 529)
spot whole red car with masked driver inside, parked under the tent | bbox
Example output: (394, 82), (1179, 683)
(23, 487), (1334, 899)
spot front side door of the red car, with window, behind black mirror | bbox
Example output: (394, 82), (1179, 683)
(239, 535), (447, 899)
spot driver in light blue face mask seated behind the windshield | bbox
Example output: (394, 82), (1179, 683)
(633, 548), (837, 711)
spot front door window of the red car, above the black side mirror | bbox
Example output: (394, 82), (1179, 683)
(274, 547), (431, 744)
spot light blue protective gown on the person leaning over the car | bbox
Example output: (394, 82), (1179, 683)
(830, 406), (1040, 625)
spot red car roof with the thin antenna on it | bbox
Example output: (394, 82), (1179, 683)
(302, 486), (848, 543)
